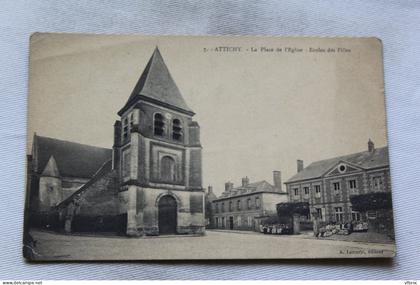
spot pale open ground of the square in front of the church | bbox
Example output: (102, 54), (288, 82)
(27, 230), (395, 260)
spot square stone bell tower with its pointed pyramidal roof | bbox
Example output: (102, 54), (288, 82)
(113, 48), (205, 236)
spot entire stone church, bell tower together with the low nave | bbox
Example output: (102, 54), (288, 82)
(26, 47), (205, 236)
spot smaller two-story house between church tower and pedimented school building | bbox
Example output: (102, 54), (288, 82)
(212, 171), (287, 230)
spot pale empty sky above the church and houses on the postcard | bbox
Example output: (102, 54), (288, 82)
(27, 34), (387, 194)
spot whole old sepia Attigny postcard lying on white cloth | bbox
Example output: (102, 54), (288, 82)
(23, 33), (396, 261)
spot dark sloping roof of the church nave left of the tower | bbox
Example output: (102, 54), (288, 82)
(32, 135), (112, 178)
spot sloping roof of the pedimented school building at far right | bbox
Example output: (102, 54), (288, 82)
(286, 147), (389, 183)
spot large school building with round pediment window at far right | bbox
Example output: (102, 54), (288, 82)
(285, 140), (391, 222)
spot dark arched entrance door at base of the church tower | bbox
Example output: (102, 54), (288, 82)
(158, 195), (177, 235)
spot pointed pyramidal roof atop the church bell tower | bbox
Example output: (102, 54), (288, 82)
(118, 47), (194, 115)
